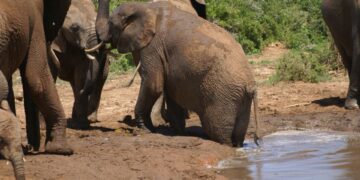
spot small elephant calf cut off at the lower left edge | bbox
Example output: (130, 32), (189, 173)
(0, 71), (25, 180)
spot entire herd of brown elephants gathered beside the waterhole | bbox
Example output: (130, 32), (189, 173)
(0, 0), (360, 179)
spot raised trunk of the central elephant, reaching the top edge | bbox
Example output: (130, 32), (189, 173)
(95, 0), (111, 43)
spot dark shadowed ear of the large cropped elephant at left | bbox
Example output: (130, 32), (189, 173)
(43, 0), (71, 42)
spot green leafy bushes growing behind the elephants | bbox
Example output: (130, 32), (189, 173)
(93, 0), (340, 83)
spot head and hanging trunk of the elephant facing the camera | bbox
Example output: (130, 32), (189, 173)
(51, 0), (106, 96)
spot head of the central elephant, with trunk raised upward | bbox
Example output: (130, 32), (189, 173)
(96, 0), (157, 53)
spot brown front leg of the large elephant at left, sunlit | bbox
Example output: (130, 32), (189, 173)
(21, 22), (73, 155)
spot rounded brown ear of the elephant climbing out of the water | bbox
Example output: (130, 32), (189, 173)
(117, 7), (157, 53)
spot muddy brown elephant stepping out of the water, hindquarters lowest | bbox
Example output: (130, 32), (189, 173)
(96, 0), (258, 147)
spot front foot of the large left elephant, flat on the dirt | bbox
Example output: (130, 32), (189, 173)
(45, 141), (74, 155)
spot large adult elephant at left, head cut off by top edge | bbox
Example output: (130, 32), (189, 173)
(0, 0), (73, 155)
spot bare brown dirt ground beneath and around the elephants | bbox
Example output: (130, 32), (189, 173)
(0, 44), (360, 180)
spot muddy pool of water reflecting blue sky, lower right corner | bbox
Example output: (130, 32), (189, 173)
(218, 131), (360, 180)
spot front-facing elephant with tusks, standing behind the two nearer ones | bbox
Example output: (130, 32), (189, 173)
(49, 0), (109, 129)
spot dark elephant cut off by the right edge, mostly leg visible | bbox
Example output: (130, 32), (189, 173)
(321, 0), (360, 109)
